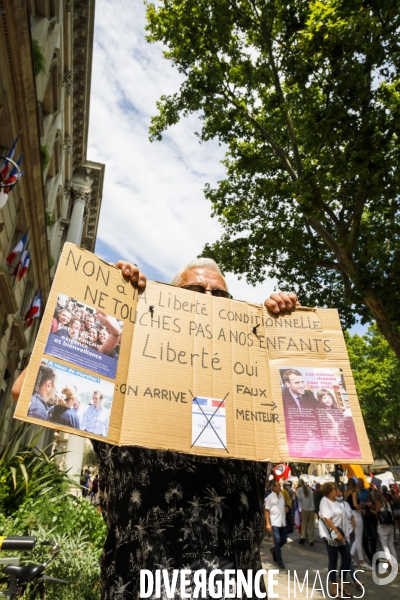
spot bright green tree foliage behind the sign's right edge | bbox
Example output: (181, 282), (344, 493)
(346, 325), (400, 465)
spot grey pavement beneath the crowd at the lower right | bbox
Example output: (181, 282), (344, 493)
(261, 532), (400, 600)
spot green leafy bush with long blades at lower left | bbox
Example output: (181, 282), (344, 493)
(0, 424), (106, 600)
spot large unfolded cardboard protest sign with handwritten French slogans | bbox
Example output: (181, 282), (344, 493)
(16, 244), (372, 464)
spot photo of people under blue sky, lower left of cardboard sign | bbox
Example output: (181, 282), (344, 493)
(28, 360), (114, 437)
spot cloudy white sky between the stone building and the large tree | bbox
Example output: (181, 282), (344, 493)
(88, 0), (273, 302)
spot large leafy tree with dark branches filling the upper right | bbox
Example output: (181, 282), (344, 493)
(147, 0), (400, 358)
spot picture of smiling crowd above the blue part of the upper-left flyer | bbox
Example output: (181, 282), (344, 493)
(50, 298), (122, 358)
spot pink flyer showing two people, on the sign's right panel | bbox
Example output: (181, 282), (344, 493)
(279, 367), (361, 458)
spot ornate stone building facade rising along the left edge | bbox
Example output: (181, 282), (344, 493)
(0, 0), (105, 448)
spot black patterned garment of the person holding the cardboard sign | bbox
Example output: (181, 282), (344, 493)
(93, 442), (266, 600)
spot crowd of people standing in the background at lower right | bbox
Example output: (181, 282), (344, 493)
(265, 477), (400, 597)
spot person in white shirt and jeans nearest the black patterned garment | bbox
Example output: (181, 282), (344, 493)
(265, 481), (287, 569)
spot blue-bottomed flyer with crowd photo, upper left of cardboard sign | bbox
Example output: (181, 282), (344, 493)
(45, 293), (123, 379)
